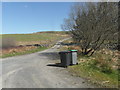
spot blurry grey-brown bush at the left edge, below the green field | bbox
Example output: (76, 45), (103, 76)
(0, 37), (16, 49)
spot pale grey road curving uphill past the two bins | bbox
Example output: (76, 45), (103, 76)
(0, 40), (94, 88)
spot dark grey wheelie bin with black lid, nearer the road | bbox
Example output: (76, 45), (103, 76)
(59, 51), (71, 67)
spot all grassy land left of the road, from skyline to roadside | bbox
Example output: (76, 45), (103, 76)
(0, 31), (68, 58)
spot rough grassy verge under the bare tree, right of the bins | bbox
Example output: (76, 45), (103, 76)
(60, 39), (120, 88)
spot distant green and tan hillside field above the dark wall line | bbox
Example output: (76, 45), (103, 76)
(0, 32), (66, 45)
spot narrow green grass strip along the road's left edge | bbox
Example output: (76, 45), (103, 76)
(0, 47), (47, 58)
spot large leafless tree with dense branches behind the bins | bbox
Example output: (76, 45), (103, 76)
(62, 2), (118, 55)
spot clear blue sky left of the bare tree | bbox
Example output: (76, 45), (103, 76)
(2, 2), (73, 34)
